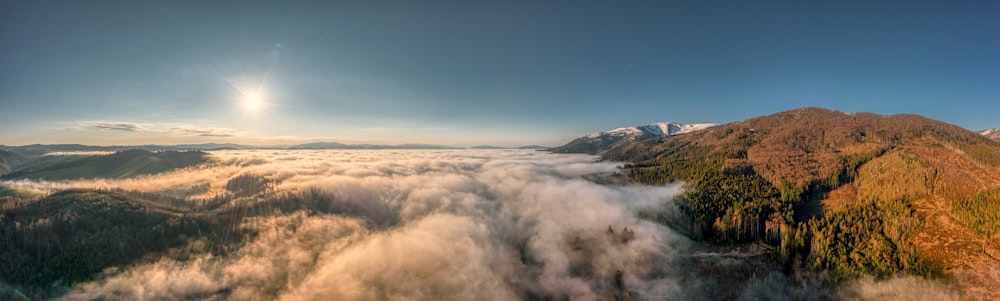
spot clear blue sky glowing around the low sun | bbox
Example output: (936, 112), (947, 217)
(0, 0), (1000, 145)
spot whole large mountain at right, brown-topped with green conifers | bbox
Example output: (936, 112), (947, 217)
(605, 108), (1000, 298)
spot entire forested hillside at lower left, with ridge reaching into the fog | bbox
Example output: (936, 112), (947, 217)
(0, 174), (368, 300)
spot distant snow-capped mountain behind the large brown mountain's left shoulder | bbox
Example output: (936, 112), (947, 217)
(549, 122), (715, 155)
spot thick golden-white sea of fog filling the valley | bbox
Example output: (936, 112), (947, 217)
(1, 150), (960, 300)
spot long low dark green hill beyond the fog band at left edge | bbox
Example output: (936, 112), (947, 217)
(2, 149), (208, 180)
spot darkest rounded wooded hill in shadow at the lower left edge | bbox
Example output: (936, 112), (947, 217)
(0, 190), (199, 287)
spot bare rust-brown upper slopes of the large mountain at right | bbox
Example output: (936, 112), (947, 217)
(607, 108), (1000, 186)
